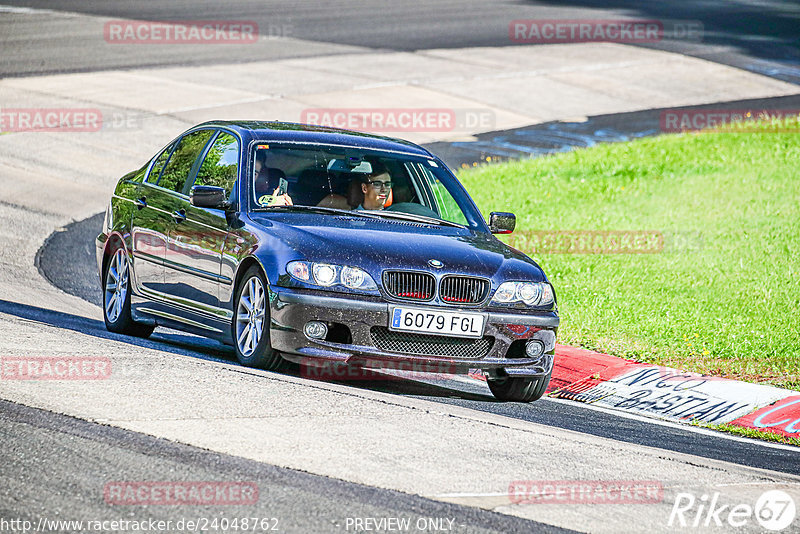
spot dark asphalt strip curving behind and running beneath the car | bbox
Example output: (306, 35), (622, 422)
(34, 213), (800, 475)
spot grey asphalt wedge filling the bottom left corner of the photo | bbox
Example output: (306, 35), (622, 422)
(0, 400), (572, 534)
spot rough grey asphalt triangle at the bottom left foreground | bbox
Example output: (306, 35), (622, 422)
(0, 401), (570, 533)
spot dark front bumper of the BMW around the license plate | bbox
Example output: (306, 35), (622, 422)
(270, 287), (559, 377)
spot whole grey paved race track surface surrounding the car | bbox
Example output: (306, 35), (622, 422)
(0, 0), (800, 533)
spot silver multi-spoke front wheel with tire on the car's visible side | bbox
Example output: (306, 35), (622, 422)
(233, 265), (286, 371)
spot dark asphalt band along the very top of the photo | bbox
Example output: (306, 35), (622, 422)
(0, 0), (800, 83)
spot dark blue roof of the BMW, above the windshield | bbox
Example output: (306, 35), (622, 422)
(196, 121), (433, 157)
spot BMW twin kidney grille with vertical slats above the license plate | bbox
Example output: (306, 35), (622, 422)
(383, 271), (490, 305)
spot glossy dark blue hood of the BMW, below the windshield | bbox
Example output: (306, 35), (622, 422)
(251, 213), (546, 281)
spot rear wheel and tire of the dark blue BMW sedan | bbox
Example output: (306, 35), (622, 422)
(103, 244), (156, 338)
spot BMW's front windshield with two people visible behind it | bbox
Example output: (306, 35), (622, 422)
(249, 142), (484, 229)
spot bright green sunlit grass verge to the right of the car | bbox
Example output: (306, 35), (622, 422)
(459, 119), (800, 389)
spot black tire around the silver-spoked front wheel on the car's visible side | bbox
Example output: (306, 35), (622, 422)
(231, 265), (289, 371)
